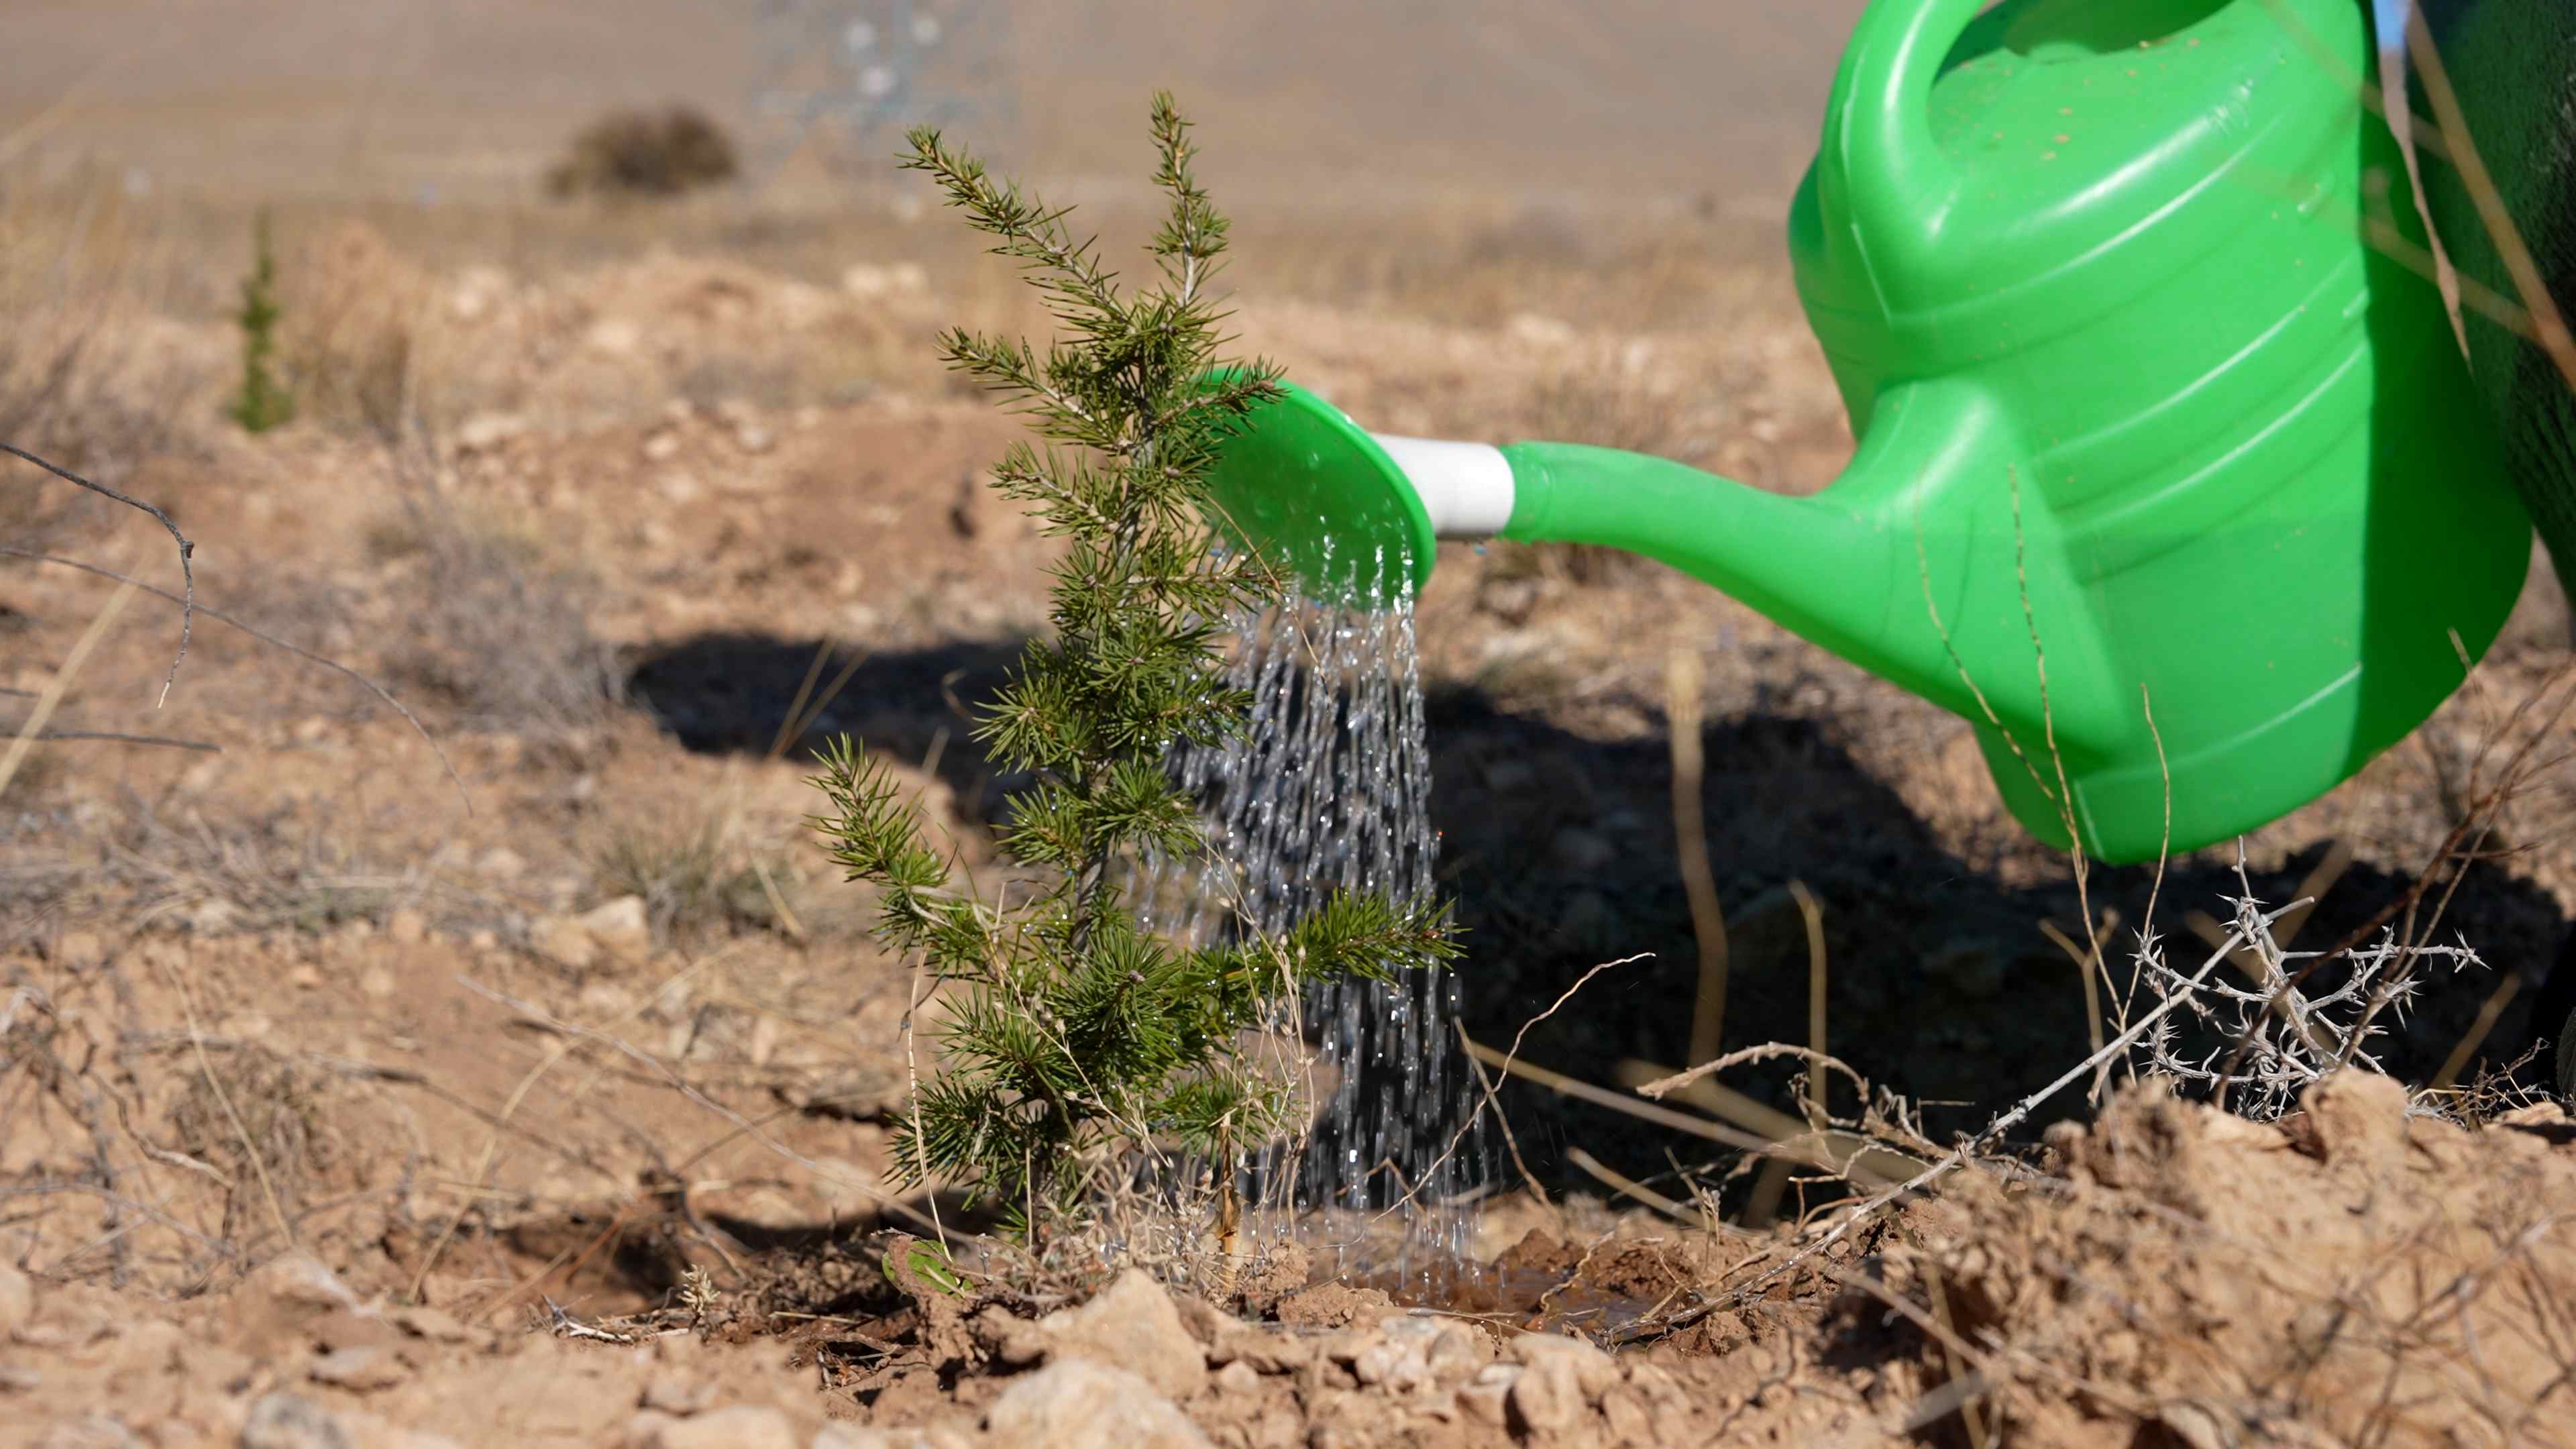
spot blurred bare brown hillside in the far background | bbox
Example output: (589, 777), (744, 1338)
(0, 0), (1860, 217)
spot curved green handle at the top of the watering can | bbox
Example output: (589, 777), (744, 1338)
(1819, 0), (1986, 286)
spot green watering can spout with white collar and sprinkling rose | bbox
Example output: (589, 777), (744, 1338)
(1214, 379), (2138, 838)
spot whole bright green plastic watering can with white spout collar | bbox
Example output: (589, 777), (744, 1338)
(1214, 0), (2532, 861)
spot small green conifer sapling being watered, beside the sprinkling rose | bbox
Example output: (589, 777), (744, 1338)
(814, 95), (1456, 1250)
